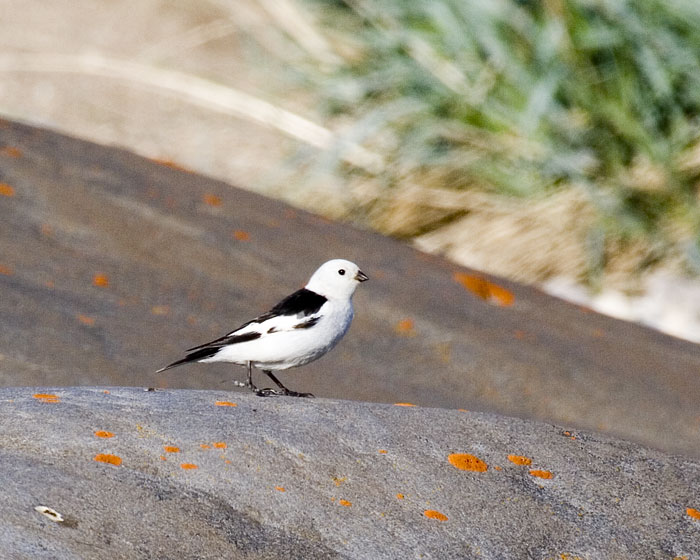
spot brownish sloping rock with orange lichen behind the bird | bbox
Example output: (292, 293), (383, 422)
(0, 121), (700, 457)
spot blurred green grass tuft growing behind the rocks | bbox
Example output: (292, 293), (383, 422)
(298, 0), (700, 278)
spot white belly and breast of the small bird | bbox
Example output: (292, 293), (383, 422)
(202, 304), (353, 370)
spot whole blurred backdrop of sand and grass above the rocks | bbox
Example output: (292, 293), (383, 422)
(0, 0), (700, 341)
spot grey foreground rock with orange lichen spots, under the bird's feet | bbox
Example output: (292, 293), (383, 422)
(0, 387), (700, 560)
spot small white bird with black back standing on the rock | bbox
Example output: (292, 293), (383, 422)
(156, 259), (369, 397)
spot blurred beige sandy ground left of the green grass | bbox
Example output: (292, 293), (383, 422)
(0, 0), (320, 195)
